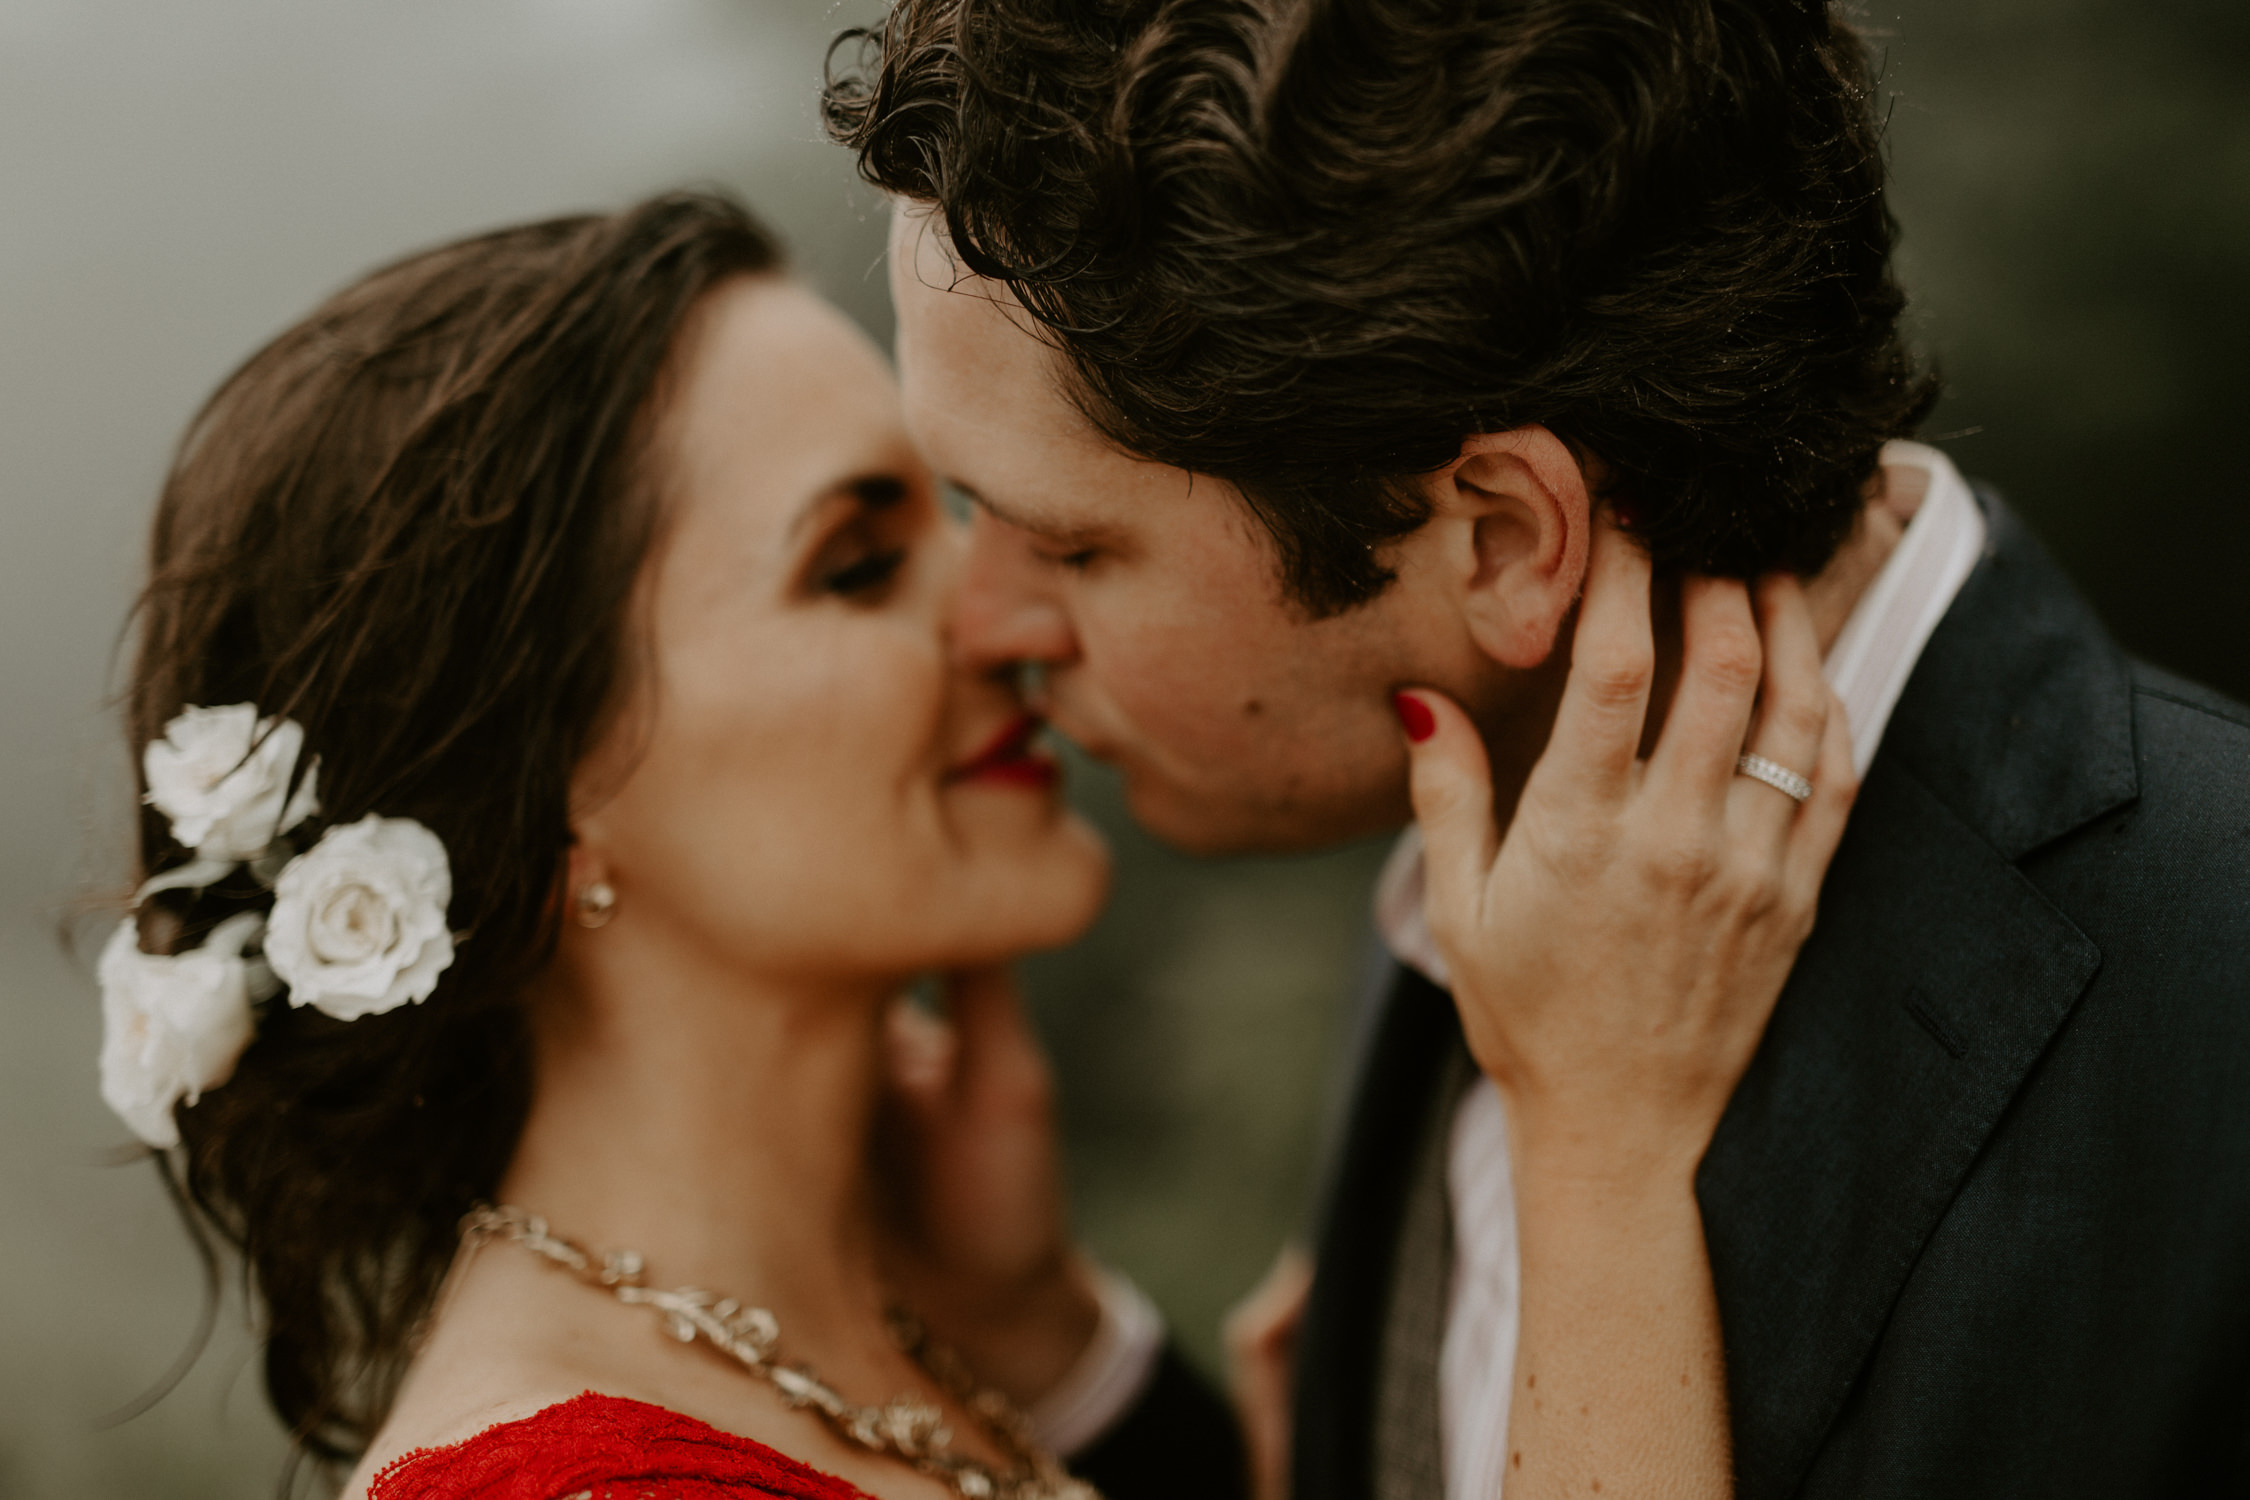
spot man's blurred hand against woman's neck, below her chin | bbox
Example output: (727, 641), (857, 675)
(878, 969), (1100, 1406)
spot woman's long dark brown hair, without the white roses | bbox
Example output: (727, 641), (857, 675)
(126, 193), (779, 1460)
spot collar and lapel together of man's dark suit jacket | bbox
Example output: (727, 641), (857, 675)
(1697, 501), (2135, 1500)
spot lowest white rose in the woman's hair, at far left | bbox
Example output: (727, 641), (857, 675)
(101, 913), (261, 1147)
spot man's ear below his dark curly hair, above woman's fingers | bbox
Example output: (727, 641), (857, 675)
(1431, 427), (1593, 668)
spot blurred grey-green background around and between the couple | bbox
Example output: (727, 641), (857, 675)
(0, 0), (2250, 1500)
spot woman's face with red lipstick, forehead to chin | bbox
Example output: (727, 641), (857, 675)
(574, 277), (1107, 981)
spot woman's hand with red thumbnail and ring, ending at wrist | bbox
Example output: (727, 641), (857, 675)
(1400, 526), (1856, 1176)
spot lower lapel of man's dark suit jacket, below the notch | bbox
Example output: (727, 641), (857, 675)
(1697, 767), (2099, 1500)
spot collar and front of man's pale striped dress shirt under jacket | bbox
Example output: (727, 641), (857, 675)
(1375, 443), (1985, 1500)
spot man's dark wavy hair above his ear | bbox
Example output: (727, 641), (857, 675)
(826, 0), (1935, 614)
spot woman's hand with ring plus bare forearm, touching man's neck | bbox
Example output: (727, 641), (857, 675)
(1400, 526), (1856, 1500)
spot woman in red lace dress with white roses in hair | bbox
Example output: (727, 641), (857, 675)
(104, 196), (1850, 1500)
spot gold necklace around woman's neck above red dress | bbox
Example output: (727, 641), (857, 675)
(461, 1203), (1100, 1500)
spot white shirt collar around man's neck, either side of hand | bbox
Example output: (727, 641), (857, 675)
(1375, 443), (1987, 987)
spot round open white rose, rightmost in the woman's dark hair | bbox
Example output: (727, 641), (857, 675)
(266, 814), (452, 1021)
